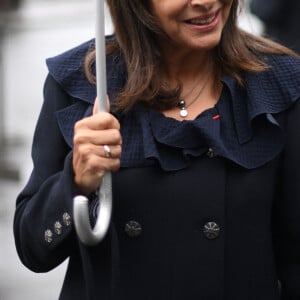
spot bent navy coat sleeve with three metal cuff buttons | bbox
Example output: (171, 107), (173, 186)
(14, 75), (87, 272)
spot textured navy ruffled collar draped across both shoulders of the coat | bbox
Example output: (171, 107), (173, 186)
(47, 41), (300, 171)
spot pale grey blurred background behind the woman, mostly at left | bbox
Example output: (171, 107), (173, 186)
(0, 0), (286, 300)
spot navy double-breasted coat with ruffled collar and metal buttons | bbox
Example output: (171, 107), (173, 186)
(14, 42), (300, 300)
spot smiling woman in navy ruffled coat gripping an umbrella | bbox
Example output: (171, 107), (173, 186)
(14, 0), (300, 300)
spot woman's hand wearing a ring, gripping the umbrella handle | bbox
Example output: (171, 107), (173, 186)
(73, 101), (122, 195)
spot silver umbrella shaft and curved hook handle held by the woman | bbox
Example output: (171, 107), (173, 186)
(73, 0), (112, 246)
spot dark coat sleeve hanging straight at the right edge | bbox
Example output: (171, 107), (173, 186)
(274, 100), (300, 300)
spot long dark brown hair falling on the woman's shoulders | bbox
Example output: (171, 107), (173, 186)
(85, 0), (296, 110)
